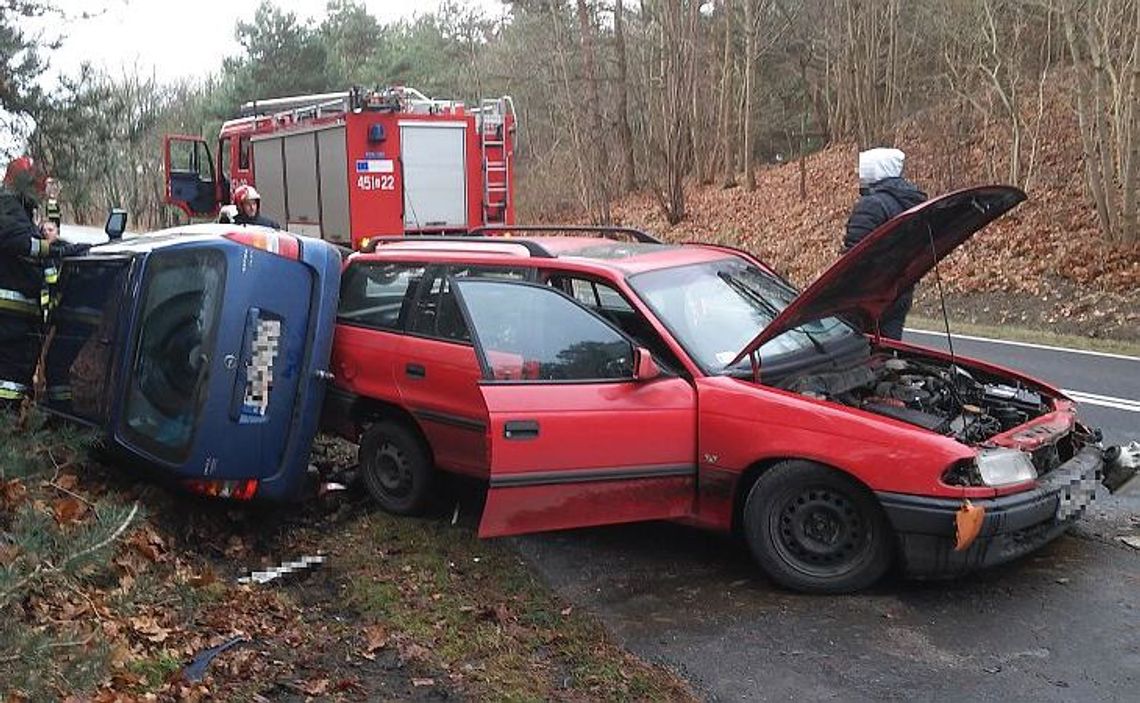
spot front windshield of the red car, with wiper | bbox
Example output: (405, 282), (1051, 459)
(629, 258), (856, 374)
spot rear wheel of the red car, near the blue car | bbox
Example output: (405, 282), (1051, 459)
(359, 422), (434, 515)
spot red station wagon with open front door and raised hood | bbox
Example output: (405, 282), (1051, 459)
(326, 187), (1104, 592)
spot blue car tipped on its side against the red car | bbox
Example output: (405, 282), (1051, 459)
(44, 224), (341, 500)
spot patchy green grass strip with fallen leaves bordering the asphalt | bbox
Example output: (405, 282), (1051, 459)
(334, 513), (692, 701)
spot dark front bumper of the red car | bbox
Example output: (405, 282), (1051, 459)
(876, 447), (1105, 579)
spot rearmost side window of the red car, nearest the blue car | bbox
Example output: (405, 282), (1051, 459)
(337, 261), (424, 330)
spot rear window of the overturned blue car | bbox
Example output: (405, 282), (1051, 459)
(122, 250), (226, 464)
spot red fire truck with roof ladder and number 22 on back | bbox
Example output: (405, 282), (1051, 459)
(164, 87), (515, 248)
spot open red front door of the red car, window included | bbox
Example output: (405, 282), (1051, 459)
(451, 278), (697, 537)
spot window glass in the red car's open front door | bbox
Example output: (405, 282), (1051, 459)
(454, 279), (634, 382)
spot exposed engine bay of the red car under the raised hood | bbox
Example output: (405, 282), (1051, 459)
(780, 354), (1052, 444)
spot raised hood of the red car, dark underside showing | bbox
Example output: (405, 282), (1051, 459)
(728, 186), (1026, 366)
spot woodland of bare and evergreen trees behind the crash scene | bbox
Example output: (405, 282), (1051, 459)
(0, 0), (1140, 250)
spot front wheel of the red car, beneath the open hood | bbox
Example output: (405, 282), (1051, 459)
(743, 460), (894, 594)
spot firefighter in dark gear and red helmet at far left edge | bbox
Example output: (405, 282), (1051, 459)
(0, 156), (86, 410)
